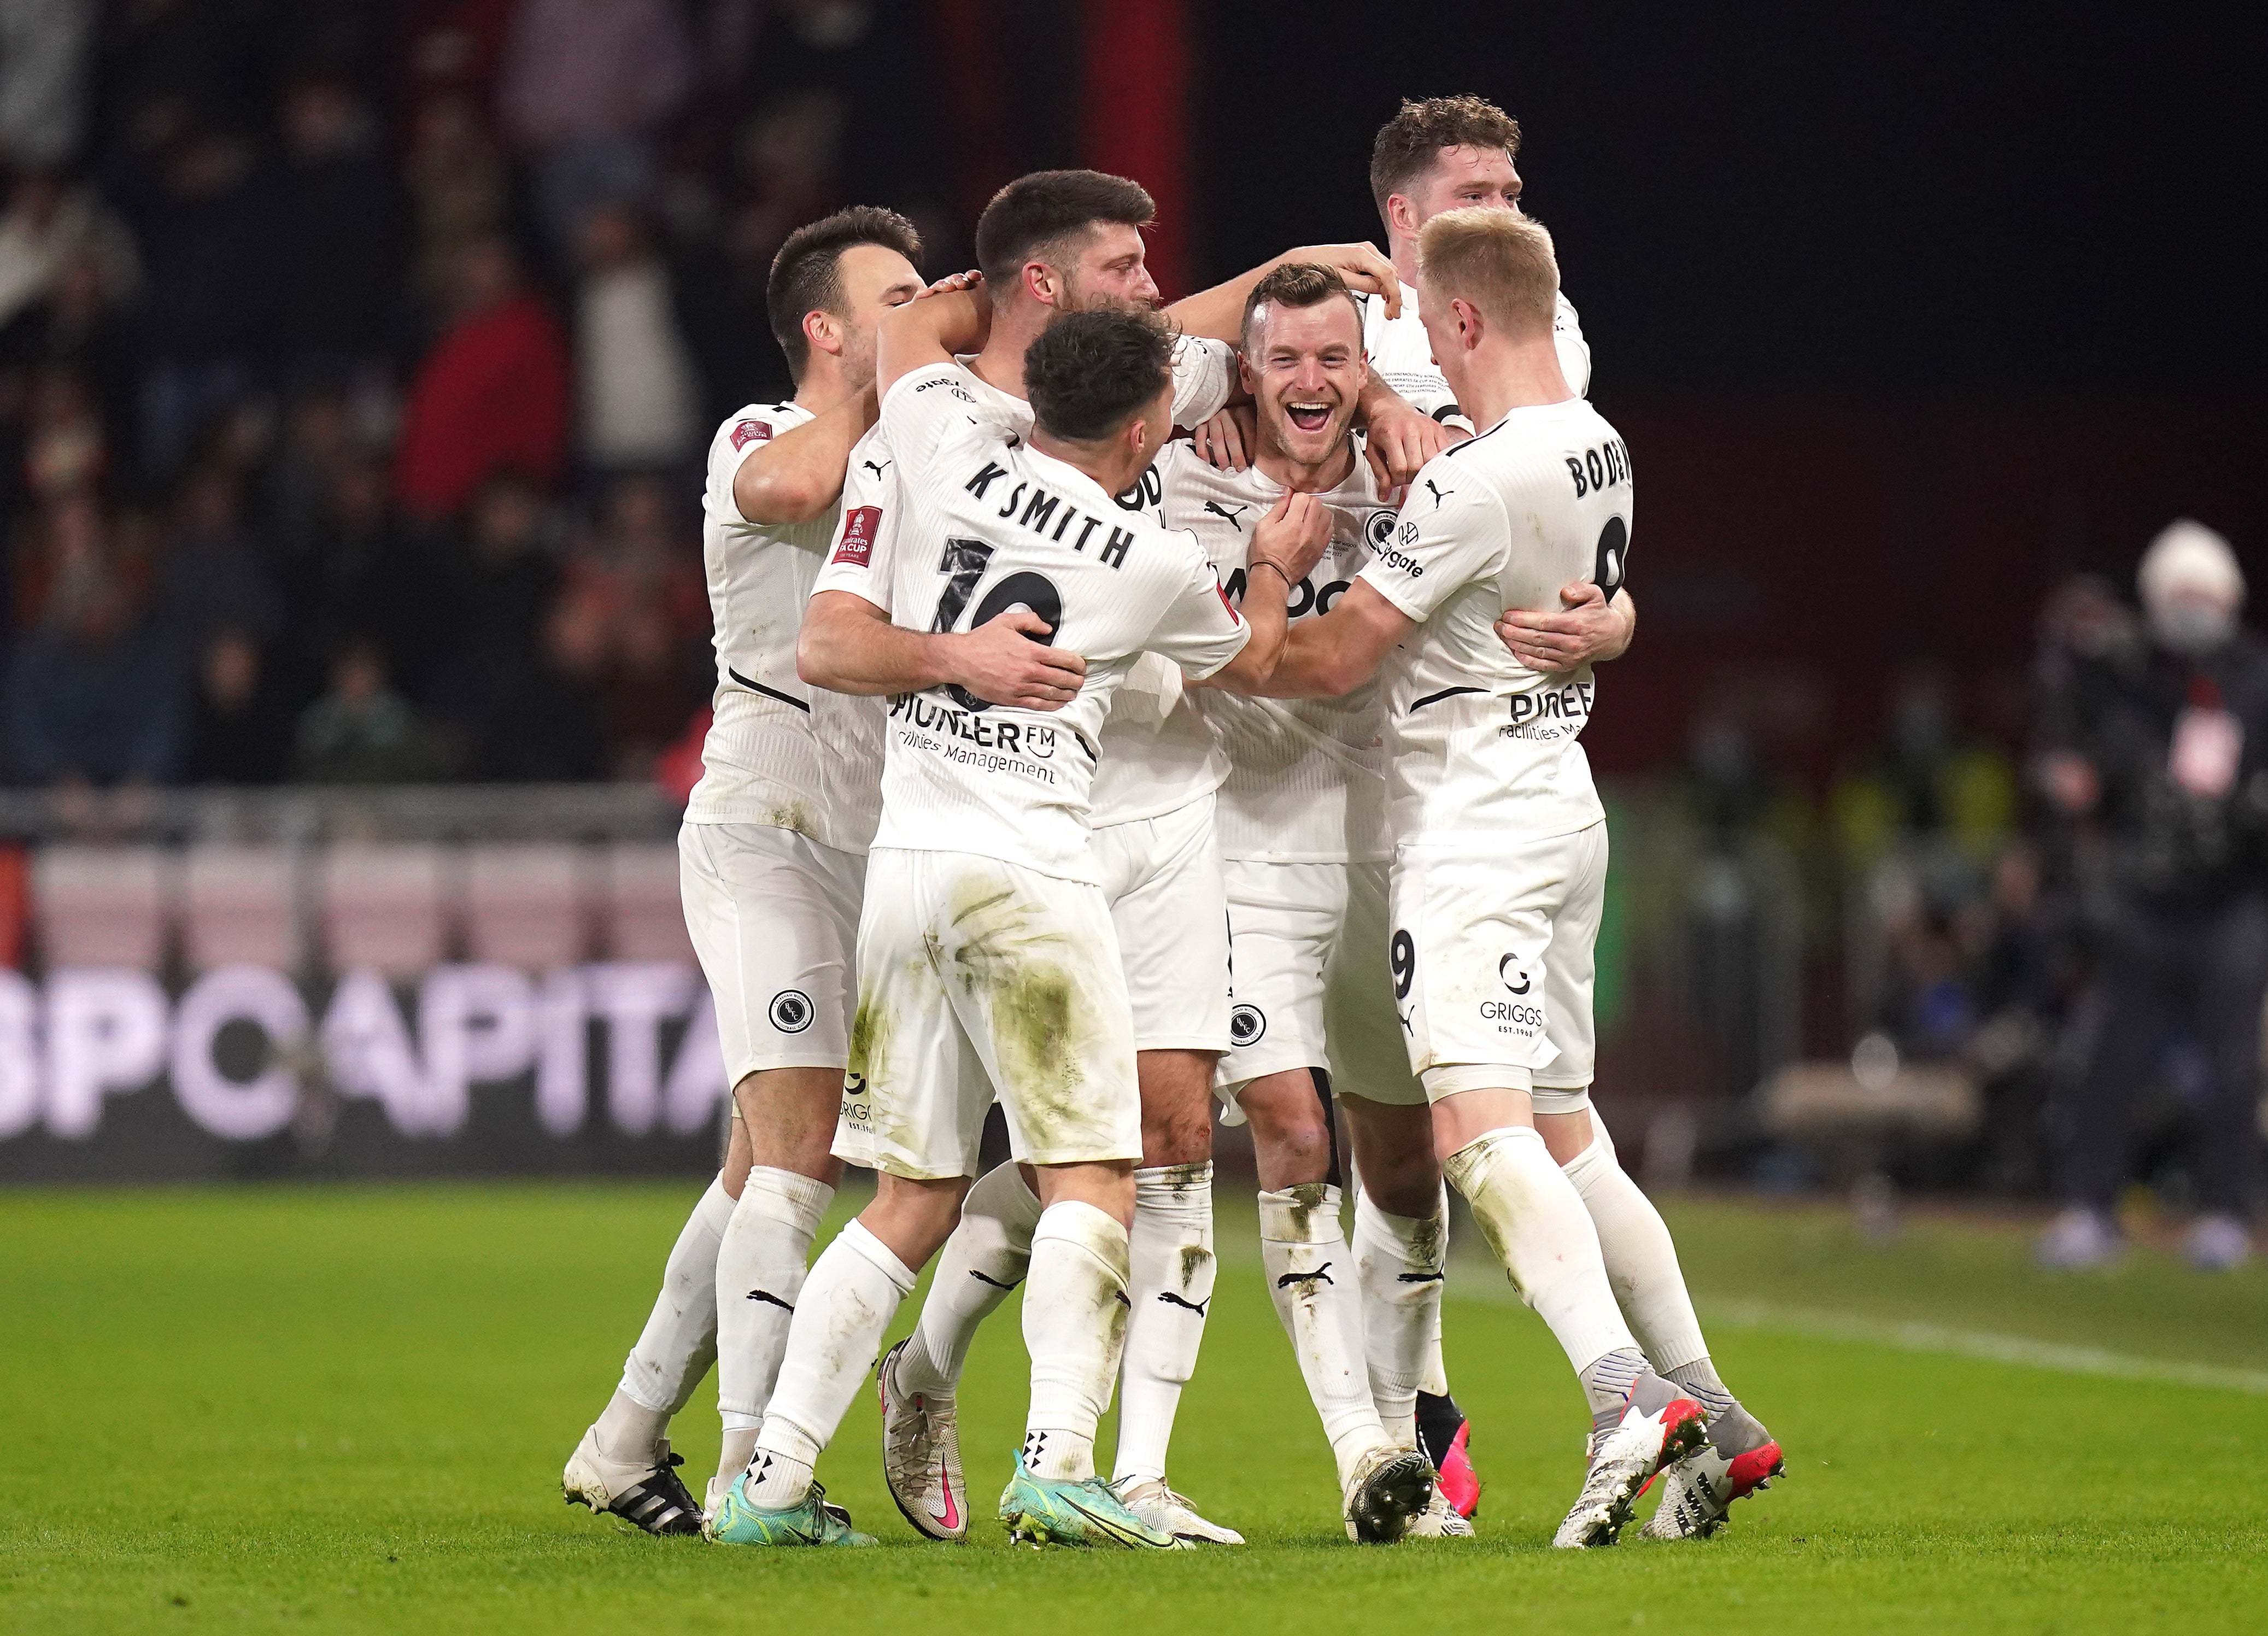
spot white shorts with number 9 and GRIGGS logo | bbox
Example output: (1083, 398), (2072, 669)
(1388, 824), (1605, 1114)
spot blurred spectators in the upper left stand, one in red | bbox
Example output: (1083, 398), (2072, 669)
(0, 0), (934, 787)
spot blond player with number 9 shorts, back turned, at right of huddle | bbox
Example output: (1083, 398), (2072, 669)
(1234, 209), (1780, 1547)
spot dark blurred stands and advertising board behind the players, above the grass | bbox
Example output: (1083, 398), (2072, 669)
(0, 0), (2264, 1196)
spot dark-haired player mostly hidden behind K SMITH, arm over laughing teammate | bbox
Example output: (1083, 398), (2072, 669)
(803, 170), (1438, 1545)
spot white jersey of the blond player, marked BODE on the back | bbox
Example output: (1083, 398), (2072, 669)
(1361, 397), (1631, 842)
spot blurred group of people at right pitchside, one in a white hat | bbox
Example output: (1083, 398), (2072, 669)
(1685, 522), (2268, 1269)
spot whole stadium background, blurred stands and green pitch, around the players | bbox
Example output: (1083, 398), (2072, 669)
(0, 0), (2268, 1636)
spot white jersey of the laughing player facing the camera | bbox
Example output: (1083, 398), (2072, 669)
(1152, 442), (1395, 862)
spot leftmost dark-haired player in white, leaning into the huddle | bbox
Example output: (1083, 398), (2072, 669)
(562, 207), (1039, 1534)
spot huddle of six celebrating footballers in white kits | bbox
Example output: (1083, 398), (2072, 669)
(565, 98), (1780, 1550)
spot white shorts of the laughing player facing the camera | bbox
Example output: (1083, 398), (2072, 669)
(1214, 860), (1425, 1105)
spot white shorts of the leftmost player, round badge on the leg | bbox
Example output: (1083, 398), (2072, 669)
(678, 824), (866, 1084)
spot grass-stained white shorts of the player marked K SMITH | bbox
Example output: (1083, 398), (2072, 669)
(835, 846), (1141, 1180)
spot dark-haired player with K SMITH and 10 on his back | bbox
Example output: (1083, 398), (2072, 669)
(712, 290), (1369, 1550)
